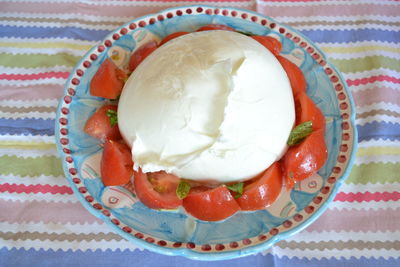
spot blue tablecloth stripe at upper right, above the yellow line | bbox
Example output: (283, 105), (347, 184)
(301, 29), (400, 43)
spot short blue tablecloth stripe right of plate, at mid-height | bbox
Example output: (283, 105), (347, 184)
(357, 121), (400, 142)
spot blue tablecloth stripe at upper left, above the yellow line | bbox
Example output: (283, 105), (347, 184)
(0, 26), (110, 41)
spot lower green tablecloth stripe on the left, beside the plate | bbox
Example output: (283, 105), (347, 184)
(0, 156), (64, 176)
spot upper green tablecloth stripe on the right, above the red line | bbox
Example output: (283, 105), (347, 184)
(330, 56), (400, 73)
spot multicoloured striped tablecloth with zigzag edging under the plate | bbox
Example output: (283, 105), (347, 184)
(0, 0), (400, 266)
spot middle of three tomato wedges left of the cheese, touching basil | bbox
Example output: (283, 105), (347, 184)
(84, 105), (121, 142)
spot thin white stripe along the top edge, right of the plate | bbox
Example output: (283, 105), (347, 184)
(257, 0), (397, 8)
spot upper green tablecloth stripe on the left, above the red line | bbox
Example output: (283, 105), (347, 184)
(0, 53), (81, 68)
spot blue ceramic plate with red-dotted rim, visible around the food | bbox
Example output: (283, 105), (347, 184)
(56, 5), (357, 260)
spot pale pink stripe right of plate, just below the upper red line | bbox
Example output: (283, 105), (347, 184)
(352, 87), (400, 107)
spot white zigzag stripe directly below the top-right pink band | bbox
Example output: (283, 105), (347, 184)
(274, 14), (399, 23)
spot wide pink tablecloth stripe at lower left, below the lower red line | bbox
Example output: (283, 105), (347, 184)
(0, 199), (102, 224)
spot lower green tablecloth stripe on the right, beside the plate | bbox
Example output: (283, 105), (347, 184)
(346, 162), (400, 184)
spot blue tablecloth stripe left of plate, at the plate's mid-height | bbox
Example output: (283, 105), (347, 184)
(0, 118), (55, 136)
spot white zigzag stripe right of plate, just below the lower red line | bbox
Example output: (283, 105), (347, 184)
(328, 200), (400, 211)
